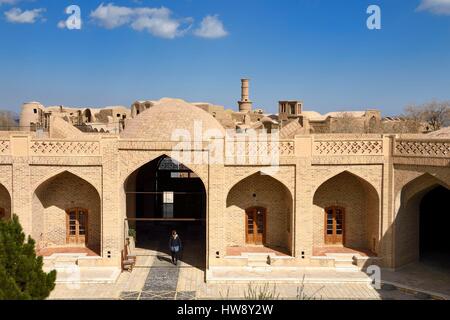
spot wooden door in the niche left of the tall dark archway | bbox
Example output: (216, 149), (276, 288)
(67, 208), (88, 245)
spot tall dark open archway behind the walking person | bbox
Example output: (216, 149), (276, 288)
(125, 156), (206, 269)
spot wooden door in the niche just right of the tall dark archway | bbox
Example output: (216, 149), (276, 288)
(245, 207), (267, 245)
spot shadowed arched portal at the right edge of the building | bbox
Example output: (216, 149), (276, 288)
(395, 174), (450, 270)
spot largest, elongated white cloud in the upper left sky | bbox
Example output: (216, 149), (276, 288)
(90, 3), (192, 39)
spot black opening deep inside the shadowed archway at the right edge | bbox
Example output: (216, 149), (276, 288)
(420, 186), (450, 268)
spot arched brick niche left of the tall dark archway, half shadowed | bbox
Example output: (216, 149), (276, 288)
(32, 171), (101, 255)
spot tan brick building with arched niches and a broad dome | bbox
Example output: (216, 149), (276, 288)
(0, 81), (450, 280)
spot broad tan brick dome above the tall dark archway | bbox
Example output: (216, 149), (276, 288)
(120, 98), (225, 141)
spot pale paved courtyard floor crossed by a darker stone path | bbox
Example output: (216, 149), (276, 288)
(50, 235), (449, 300)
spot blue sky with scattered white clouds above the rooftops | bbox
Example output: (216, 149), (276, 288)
(0, 0), (450, 115)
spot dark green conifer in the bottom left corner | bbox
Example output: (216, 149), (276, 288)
(0, 215), (56, 300)
